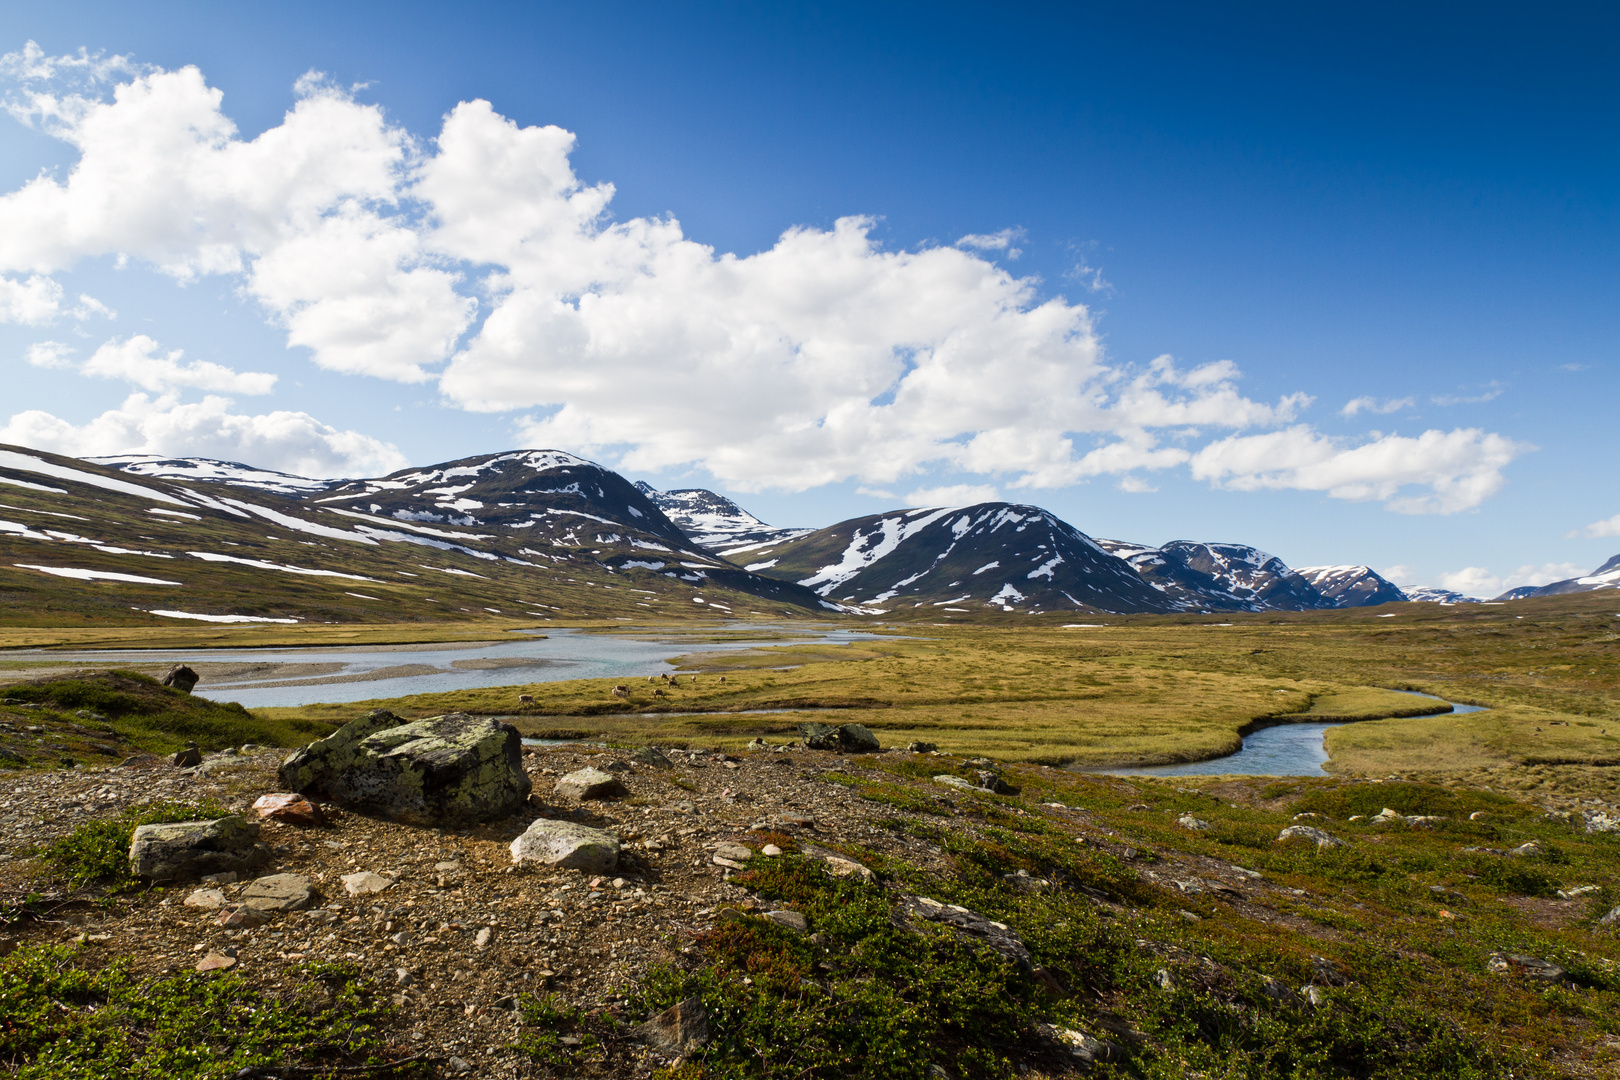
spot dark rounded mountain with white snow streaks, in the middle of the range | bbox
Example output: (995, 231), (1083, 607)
(727, 502), (1171, 612)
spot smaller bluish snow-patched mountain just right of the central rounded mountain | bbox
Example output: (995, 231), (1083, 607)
(1097, 539), (1337, 610)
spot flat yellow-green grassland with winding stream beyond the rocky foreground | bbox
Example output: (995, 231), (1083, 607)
(261, 594), (1620, 795)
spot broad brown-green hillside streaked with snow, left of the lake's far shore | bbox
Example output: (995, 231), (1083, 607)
(0, 447), (823, 627)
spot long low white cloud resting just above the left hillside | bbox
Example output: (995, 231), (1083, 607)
(0, 393), (408, 476)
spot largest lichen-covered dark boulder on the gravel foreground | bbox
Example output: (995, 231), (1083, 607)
(280, 709), (533, 826)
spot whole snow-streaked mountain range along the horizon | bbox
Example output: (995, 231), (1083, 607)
(0, 447), (1620, 619)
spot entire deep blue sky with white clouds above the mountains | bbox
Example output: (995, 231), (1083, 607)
(0, 3), (1620, 593)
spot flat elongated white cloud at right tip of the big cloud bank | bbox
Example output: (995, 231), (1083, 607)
(1192, 424), (1534, 513)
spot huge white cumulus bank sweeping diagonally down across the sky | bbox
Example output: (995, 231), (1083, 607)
(0, 45), (1518, 512)
